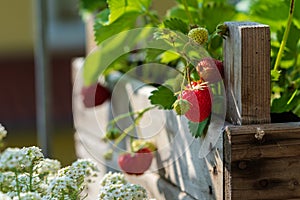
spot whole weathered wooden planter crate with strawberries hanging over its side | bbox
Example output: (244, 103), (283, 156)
(73, 22), (300, 200)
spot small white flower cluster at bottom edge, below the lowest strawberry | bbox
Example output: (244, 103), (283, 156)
(99, 172), (148, 200)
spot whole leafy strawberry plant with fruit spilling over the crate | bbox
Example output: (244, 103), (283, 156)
(78, 0), (300, 173)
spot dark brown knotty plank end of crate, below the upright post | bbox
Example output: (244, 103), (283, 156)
(224, 122), (300, 199)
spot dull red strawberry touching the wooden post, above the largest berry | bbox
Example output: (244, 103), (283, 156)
(196, 57), (224, 83)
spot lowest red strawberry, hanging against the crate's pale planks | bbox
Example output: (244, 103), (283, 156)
(118, 148), (153, 175)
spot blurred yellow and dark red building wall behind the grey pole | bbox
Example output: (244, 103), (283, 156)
(0, 0), (85, 165)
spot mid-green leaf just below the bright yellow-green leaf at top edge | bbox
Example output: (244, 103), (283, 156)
(94, 12), (139, 44)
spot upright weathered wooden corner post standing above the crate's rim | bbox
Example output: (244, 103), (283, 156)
(223, 22), (270, 125)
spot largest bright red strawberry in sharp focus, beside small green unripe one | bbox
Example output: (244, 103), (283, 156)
(182, 82), (211, 122)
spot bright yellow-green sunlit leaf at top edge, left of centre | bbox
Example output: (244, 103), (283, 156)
(107, 0), (151, 23)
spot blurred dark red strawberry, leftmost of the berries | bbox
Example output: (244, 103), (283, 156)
(81, 83), (111, 108)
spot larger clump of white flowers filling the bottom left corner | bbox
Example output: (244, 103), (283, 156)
(0, 124), (97, 200)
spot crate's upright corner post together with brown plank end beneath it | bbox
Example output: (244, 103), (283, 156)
(223, 22), (300, 200)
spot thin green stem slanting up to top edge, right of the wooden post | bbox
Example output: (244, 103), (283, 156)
(274, 0), (295, 71)
